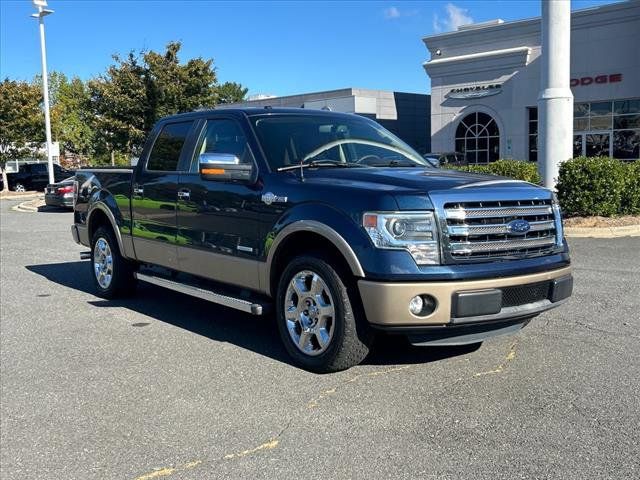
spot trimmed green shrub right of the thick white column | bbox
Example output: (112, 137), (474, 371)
(556, 157), (638, 217)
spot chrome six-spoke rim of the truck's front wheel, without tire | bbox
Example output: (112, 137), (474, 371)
(284, 270), (335, 356)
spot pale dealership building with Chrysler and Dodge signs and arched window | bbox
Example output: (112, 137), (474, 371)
(423, 0), (640, 163)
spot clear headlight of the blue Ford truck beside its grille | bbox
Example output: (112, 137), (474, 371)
(362, 212), (440, 265)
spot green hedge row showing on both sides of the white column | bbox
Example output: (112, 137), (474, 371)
(450, 157), (640, 217)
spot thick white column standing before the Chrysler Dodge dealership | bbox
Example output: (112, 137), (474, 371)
(538, 0), (573, 188)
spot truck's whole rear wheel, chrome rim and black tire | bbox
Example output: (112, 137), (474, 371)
(91, 227), (136, 298)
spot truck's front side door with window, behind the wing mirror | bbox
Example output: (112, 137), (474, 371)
(178, 115), (262, 289)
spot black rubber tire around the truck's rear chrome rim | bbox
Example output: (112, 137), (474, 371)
(90, 227), (136, 299)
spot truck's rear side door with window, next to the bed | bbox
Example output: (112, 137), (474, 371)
(131, 120), (194, 269)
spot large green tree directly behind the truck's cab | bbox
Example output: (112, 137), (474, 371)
(89, 42), (217, 155)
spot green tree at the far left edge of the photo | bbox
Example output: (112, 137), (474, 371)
(0, 78), (44, 191)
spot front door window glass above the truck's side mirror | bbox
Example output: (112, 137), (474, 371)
(196, 119), (253, 163)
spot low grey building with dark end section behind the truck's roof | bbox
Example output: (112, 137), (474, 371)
(224, 88), (431, 153)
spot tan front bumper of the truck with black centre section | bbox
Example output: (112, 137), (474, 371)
(358, 267), (573, 331)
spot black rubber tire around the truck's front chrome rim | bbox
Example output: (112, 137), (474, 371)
(276, 256), (373, 373)
